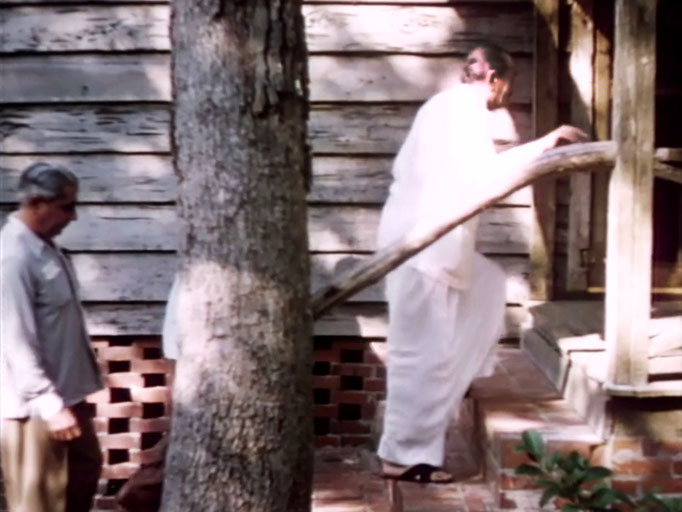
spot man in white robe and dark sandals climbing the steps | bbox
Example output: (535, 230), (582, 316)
(378, 44), (584, 483)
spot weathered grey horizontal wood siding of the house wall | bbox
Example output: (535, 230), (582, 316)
(0, 0), (534, 338)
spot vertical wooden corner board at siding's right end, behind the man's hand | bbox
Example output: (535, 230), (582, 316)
(530, 0), (559, 300)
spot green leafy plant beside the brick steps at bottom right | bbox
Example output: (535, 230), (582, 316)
(515, 430), (682, 512)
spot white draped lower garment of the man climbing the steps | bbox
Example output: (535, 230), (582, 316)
(378, 253), (505, 466)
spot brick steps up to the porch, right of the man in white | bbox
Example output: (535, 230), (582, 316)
(470, 349), (604, 511)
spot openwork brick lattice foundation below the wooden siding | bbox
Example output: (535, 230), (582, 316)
(89, 337), (385, 510)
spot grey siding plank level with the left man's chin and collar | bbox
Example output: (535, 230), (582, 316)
(0, 205), (532, 254)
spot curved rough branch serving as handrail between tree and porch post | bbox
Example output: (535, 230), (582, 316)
(311, 141), (615, 318)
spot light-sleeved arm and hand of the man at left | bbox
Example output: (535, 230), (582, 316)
(0, 259), (80, 440)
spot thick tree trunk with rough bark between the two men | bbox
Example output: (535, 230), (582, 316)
(162, 0), (312, 512)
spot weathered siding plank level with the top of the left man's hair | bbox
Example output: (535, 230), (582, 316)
(0, 155), (531, 206)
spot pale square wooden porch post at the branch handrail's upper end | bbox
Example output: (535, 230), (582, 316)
(605, 0), (656, 386)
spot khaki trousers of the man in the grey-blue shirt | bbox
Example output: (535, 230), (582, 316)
(0, 404), (102, 512)
